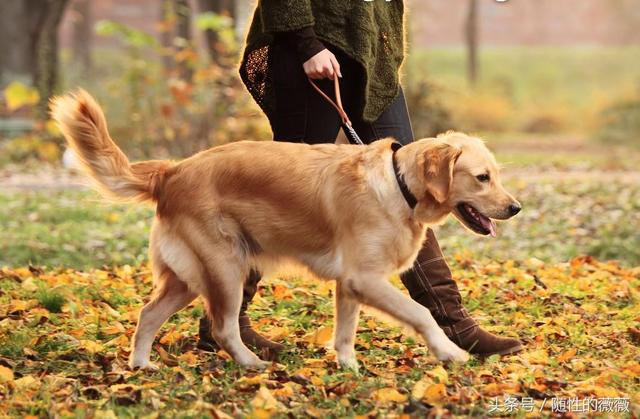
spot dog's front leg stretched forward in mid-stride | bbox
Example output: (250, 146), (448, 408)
(343, 274), (469, 362)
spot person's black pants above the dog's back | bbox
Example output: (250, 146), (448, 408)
(268, 40), (413, 144)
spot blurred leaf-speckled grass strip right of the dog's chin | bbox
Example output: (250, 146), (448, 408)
(438, 173), (640, 265)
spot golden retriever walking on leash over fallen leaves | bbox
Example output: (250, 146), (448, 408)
(52, 91), (520, 369)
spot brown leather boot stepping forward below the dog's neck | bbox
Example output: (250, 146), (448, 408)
(400, 229), (522, 356)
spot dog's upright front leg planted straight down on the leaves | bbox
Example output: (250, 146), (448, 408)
(334, 282), (360, 371)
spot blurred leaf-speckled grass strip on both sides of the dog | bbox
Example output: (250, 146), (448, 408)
(0, 174), (640, 270)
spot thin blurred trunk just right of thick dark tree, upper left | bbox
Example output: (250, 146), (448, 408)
(70, 0), (93, 77)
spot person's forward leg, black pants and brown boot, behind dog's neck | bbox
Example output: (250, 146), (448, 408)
(353, 89), (522, 356)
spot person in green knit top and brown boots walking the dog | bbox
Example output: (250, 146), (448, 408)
(198, 0), (522, 356)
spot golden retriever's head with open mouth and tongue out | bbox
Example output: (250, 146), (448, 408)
(408, 133), (521, 236)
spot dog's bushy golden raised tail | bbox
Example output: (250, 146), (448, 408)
(51, 90), (172, 201)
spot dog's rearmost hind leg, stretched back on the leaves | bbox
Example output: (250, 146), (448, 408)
(129, 267), (196, 370)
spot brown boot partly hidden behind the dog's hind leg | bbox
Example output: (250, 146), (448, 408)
(198, 270), (284, 360)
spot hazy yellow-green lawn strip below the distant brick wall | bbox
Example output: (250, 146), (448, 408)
(406, 46), (640, 109)
